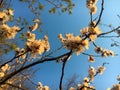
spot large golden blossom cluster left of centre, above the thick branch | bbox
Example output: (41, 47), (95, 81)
(26, 32), (50, 57)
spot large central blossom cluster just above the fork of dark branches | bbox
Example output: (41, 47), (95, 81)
(58, 33), (89, 55)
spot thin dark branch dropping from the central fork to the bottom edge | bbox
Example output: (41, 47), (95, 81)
(59, 50), (72, 90)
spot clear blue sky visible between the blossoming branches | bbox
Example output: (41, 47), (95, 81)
(13, 0), (120, 90)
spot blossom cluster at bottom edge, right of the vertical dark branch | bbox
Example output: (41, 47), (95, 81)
(69, 77), (95, 90)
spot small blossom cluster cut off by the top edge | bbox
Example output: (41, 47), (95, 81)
(87, 0), (98, 14)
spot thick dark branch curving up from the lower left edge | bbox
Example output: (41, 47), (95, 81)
(0, 51), (71, 85)
